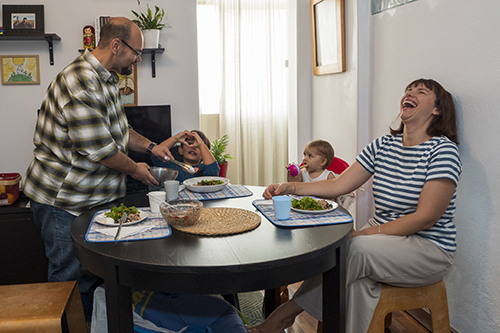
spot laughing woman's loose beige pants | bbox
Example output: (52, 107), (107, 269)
(293, 228), (454, 333)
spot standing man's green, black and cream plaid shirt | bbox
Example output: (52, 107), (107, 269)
(23, 50), (129, 215)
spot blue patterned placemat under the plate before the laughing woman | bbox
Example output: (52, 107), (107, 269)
(252, 199), (352, 227)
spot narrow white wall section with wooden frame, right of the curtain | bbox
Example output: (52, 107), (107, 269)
(297, 0), (358, 163)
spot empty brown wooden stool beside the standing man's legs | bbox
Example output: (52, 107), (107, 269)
(0, 281), (87, 333)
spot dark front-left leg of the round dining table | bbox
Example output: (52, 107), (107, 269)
(104, 266), (134, 333)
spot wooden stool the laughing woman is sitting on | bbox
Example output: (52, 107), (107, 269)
(367, 281), (451, 333)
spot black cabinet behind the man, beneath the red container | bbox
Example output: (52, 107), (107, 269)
(0, 196), (48, 285)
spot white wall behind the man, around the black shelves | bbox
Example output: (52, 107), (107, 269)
(0, 0), (199, 174)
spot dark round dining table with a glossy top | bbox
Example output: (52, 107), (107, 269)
(71, 186), (352, 333)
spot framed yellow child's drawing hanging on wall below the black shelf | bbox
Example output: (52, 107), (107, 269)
(0, 55), (40, 84)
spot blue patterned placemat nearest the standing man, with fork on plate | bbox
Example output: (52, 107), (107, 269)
(85, 207), (172, 243)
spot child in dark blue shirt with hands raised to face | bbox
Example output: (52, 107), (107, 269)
(151, 130), (220, 182)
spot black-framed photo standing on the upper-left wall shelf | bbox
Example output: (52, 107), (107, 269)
(2, 5), (45, 35)
